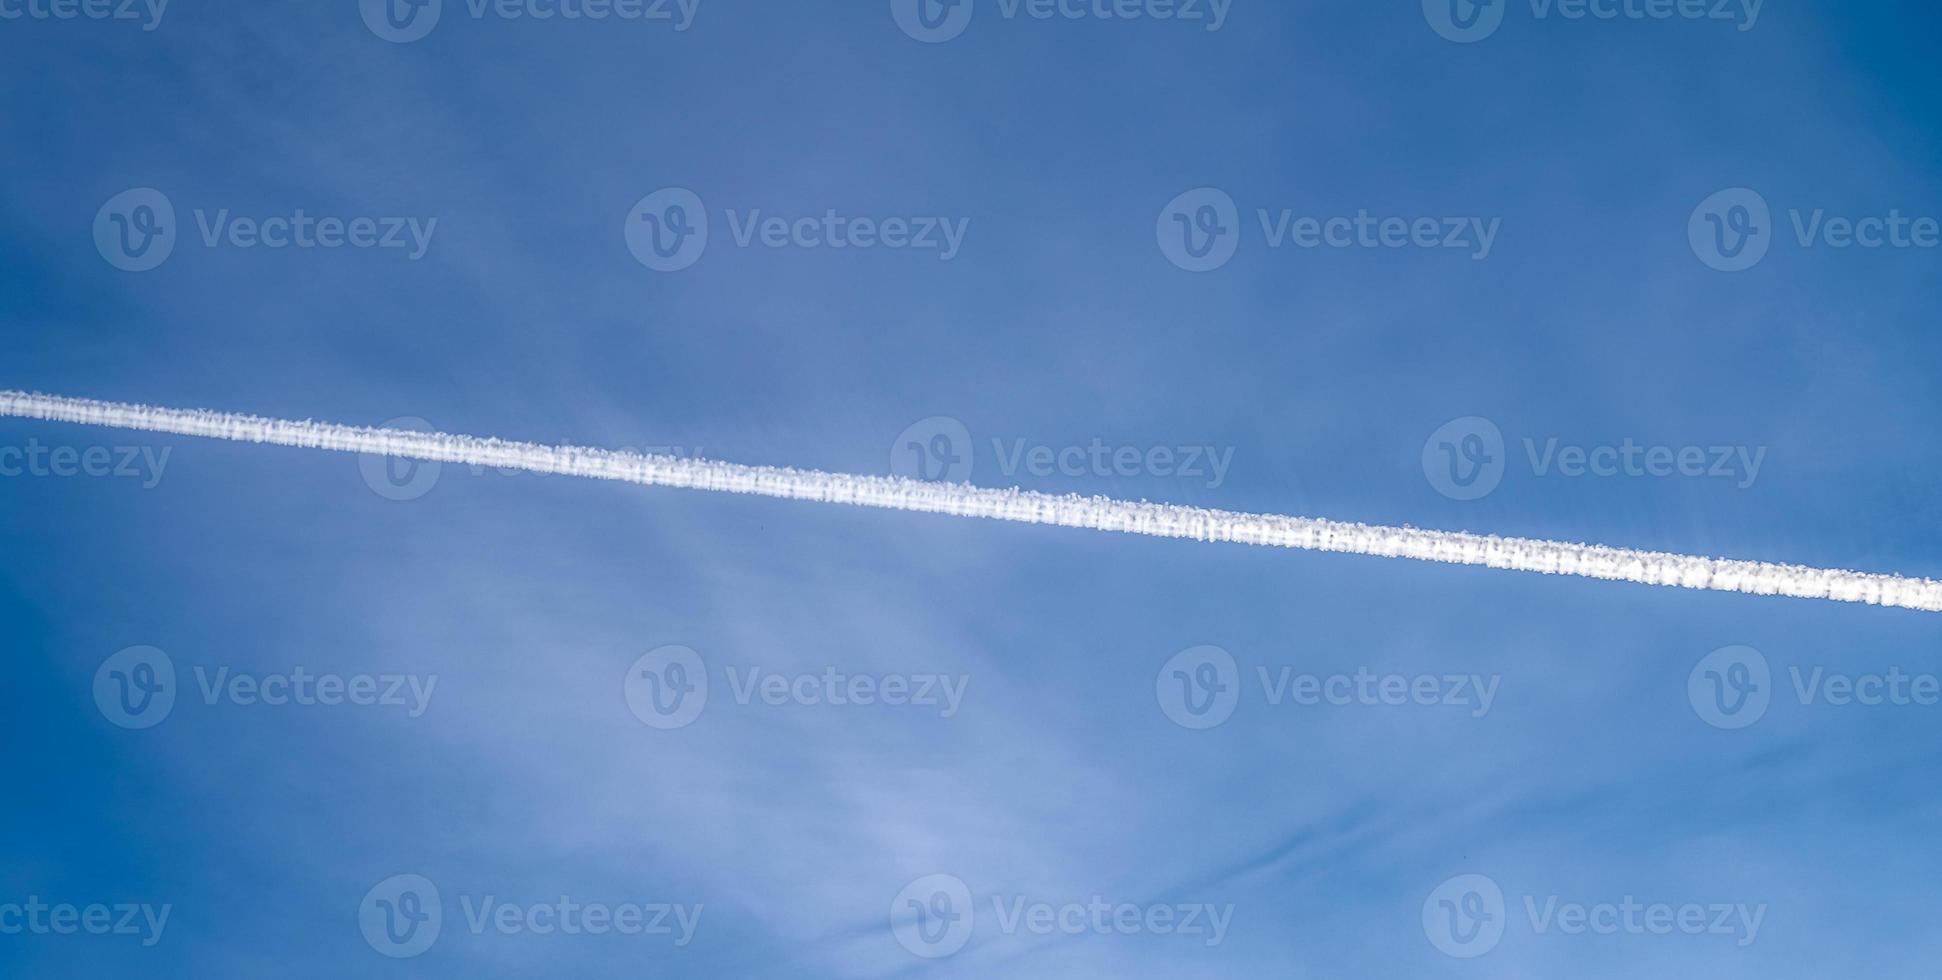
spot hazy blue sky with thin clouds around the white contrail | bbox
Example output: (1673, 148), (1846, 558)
(0, 0), (1942, 978)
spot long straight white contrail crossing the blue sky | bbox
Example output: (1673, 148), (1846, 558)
(0, 390), (1942, 611)
